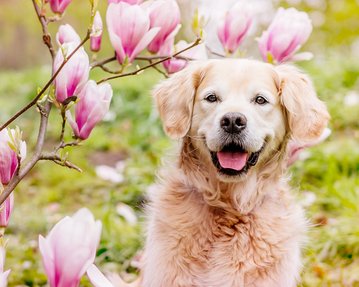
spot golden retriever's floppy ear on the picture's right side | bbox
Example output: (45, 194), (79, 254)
(275, 65), (330, 142)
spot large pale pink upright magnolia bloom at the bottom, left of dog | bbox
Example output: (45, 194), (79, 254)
(39, 208), (102, 287)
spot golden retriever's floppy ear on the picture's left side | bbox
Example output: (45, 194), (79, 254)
(153, 63), (202, 139)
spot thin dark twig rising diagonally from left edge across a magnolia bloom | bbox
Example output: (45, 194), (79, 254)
(0, 30), (90, 131)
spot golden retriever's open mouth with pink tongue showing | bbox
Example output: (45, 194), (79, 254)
(211, 144), (263, 175)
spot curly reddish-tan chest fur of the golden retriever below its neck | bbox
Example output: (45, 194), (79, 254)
(144, 180), (305, 287)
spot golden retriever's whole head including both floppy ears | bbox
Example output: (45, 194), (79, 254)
(154, 59), (329, 181)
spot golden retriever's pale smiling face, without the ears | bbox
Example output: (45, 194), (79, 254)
(193, 61), (286, 178)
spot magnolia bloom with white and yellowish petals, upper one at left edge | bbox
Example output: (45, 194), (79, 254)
(0, 129), (26, 184)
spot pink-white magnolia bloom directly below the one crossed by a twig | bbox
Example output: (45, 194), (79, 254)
(66, 80), (112, 140)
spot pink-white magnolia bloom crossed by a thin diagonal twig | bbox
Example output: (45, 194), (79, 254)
(53, 42), (90, 103)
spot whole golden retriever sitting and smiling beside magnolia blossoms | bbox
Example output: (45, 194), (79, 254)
(141, 59), (329, 287)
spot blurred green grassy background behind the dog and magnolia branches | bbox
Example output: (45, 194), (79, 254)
(0, 0), (359, 286)
